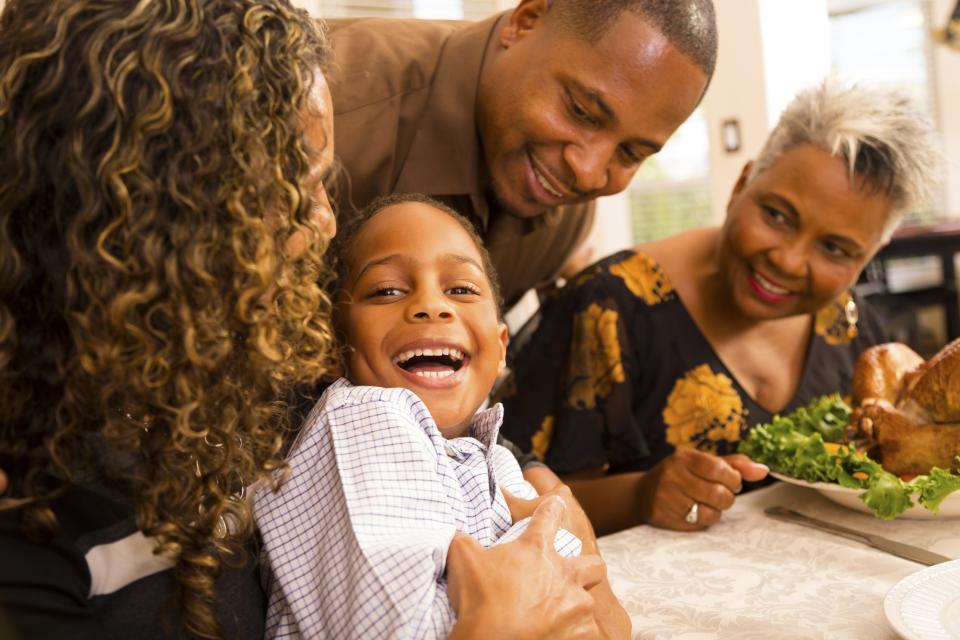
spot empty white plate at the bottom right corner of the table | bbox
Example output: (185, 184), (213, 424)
(883, 560), (960, 640)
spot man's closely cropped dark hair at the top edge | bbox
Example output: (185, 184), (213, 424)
(552, 0), (717, 81)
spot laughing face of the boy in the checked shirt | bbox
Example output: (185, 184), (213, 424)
(338, 202), (507, 438)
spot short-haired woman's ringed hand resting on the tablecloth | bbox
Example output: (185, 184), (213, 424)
(638, 449), (769, 531)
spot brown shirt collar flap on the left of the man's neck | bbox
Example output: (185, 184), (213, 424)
(394, 14), (502, 224)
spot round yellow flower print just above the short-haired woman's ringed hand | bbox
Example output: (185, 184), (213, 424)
(663, 364), (746, 452)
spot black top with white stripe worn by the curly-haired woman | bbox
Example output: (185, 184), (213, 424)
(0, 484), (266, 639)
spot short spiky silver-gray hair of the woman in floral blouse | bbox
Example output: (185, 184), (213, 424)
(749, 79), (942, 237)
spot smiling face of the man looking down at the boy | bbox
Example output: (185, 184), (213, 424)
(477, 0), (707, 217)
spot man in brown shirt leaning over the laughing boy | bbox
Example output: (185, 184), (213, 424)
(327, 0), (717, 308)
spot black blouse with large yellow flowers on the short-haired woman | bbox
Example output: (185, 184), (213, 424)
(500, 251), (885, 473)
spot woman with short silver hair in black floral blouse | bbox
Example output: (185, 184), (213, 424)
(504, 82), (938, 533)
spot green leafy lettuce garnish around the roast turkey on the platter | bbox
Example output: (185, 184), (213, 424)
(739, 394), (960, 520)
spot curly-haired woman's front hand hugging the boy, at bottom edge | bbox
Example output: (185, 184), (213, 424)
(447, 497), (606, 640)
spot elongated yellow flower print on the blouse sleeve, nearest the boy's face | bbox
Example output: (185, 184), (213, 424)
(566, 304), (624, 409)
